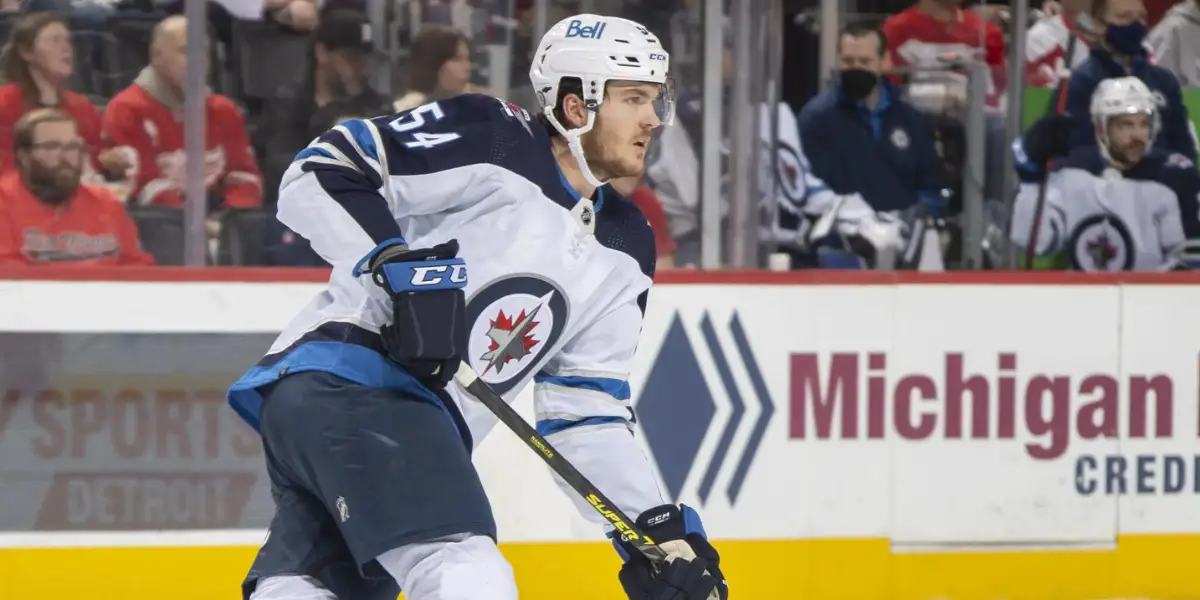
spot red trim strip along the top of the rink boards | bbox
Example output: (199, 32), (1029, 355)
(0, 266), (1200, 286)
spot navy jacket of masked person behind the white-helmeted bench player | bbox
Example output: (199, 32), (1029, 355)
(1055, 48), (1196, 162)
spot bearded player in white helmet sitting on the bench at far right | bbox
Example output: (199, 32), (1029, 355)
(1010, 77), (1200, 271)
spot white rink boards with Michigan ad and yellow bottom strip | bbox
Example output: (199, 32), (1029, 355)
(0, 275), (1200, 600)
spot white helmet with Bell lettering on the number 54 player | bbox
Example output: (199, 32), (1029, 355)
(529, 14), (674, 187)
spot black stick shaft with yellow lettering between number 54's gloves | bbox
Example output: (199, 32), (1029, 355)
(454, 361), (667, 569)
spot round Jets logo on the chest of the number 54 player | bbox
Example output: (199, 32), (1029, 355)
(467, 274), (570, 394)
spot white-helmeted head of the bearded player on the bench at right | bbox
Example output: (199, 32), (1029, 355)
(1091, 77), (1160, 169)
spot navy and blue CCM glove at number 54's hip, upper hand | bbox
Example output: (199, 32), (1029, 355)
(354, 240), (467, 389)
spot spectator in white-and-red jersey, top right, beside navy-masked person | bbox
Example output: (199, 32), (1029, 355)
(1025, 0), (1096, 88)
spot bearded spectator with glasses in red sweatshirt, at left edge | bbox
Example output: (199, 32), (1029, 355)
(0, 108), (154, 266)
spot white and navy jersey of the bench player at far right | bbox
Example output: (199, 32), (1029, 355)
(1010, 146), (1200, 271)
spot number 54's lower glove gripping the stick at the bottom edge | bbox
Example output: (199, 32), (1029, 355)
(613, 504), (730, 600)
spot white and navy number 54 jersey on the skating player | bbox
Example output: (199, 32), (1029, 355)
(229, 95), (664, 518)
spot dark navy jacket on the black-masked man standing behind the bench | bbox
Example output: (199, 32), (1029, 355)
(799, 80), (943, 211)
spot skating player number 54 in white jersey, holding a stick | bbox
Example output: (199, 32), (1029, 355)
(229, 14), (728, 600)
